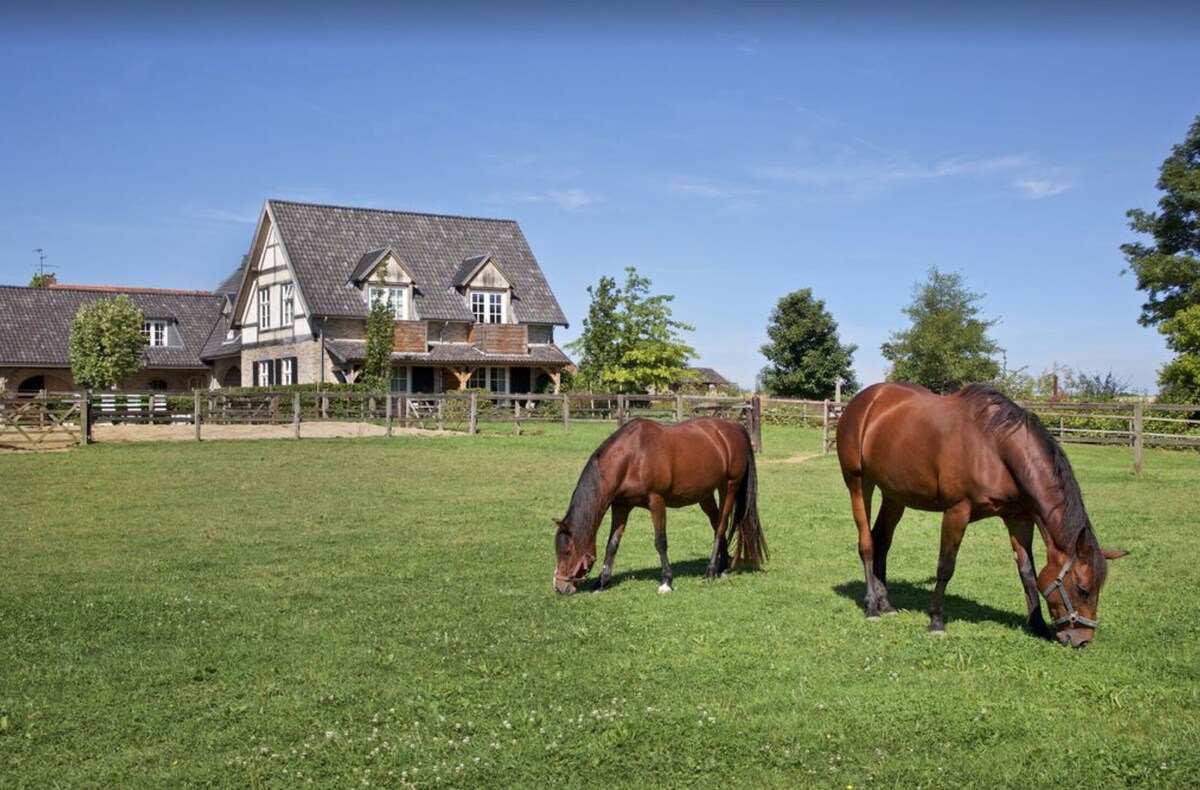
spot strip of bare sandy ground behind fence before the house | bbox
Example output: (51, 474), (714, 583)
(91, 423), (452, 443)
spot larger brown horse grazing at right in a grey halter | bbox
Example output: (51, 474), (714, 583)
(838, 383), (1126, 647)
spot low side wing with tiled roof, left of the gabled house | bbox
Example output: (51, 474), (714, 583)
(0, 285), (226, 393)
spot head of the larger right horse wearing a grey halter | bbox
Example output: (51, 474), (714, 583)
(1038, 532), (1127, 648)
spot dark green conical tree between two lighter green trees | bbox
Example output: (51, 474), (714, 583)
(760, 288), (858, 400)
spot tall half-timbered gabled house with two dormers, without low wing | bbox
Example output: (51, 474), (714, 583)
(225, 201), (570, 393)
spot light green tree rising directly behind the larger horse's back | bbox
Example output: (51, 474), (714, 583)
(881, 267), (1002, 394)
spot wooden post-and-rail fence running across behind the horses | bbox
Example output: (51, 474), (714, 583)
(0, 390), (1200, 474)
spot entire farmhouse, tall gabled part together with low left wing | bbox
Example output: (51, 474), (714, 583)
(0, 199), (570, 394)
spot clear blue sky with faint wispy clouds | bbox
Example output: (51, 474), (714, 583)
(0, 1), (1200, 390)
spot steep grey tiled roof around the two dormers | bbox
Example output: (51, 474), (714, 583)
(266, 201), (566, 327)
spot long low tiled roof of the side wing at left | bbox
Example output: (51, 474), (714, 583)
(0, 286), (224, 367)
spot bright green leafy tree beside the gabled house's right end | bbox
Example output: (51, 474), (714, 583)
(566, 267), (696, 393)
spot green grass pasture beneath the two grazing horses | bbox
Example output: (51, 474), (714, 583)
(0, 425), (1200, 788)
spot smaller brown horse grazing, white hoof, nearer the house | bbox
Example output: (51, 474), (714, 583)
(554, 418), (767, 594)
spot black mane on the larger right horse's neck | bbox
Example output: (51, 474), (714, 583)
(959, 384), (1099, 552)
